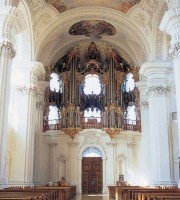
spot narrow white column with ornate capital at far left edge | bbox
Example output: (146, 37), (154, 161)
(0, 41), (15, 188)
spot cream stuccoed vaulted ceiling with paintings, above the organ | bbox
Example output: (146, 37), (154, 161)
(20, 0), (167, 67)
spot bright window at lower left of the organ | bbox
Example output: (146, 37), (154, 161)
(48, 106), (59, 124)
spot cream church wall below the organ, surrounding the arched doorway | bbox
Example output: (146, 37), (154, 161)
(41, 129), (140, 193)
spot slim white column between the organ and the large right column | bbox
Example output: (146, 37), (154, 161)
(136, 81), (150, 185)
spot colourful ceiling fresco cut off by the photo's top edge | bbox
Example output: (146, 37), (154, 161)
(46, 0), (141, 13)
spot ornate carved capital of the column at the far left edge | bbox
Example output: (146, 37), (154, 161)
(0, 41), (16, 58)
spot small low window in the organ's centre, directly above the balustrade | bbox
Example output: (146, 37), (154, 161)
(84, 108), (101, 122)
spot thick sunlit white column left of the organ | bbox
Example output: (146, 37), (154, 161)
(9, 62), (43, 185)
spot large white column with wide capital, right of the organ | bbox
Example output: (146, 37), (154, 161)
(140, 62), (174, 185)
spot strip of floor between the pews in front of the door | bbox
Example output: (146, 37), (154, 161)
(72, 194), (114, 200)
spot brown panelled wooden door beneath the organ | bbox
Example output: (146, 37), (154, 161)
(82, 157), (103, 193)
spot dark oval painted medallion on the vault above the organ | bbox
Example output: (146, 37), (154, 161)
(69, 20), (116, 38)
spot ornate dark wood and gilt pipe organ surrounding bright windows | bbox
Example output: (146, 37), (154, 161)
(44, 42), (140, 138)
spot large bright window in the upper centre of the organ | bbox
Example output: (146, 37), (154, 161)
(84, 74), (101, 95)
